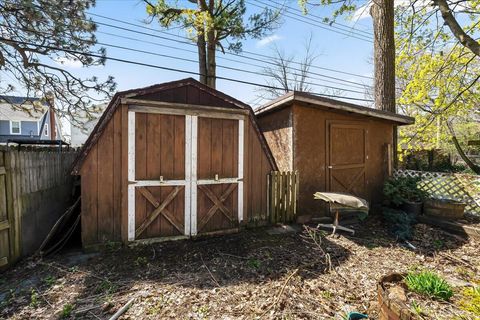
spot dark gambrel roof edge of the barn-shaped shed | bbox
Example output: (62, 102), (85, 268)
(71, 78), (277, 174)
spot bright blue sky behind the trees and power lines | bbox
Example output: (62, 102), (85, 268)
(57, 0), (373, 107)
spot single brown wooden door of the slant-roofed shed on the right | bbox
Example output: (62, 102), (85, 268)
(327, 122), (368, 199)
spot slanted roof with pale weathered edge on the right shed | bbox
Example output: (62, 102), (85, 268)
(255, 91), (415, 125)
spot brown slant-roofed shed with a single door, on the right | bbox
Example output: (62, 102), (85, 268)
(255, 92), (414, 216)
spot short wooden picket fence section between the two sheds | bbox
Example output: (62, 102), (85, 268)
(267, 171), (298, 223)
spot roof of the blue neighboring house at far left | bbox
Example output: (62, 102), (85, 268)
(0, 96), (47, 121)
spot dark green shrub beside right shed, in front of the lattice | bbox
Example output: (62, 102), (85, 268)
(383, 177), (427, 206)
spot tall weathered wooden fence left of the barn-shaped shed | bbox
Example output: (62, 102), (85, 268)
(0, 148), (76, 268)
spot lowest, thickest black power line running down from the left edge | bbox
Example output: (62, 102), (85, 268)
(0, 37), (372, 102)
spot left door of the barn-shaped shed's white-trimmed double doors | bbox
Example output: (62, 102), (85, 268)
(135, 113), (187, 239)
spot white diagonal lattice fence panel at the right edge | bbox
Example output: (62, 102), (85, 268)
(394, 170), (480, 215)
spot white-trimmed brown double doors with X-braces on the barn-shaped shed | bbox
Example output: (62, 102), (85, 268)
(128, 111), (244, 241)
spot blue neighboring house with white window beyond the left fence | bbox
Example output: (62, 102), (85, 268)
(0, 96), (63, 143)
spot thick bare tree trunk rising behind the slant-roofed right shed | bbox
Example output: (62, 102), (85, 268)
(370, 0), (396, 112)
